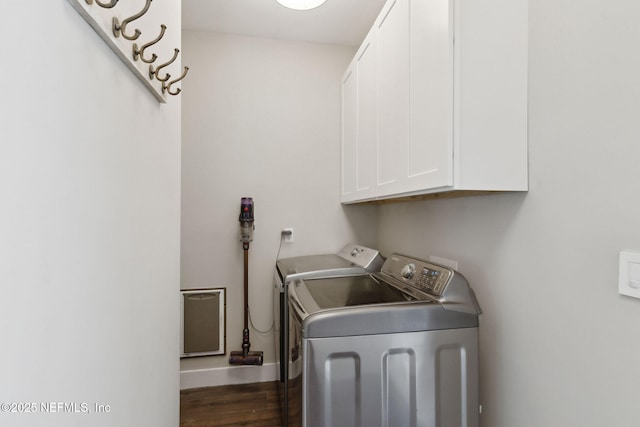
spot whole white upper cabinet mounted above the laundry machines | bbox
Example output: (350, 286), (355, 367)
(342, 0), (528, 203)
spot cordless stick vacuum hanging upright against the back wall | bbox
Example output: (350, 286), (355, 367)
(229, 197), (262, 365)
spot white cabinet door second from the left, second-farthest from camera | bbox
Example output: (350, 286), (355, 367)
(355, 32), (378, 199)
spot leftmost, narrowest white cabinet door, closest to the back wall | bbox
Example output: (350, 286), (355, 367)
(341, 62), (358, 202)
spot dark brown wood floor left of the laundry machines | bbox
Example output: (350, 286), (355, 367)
(180, 382), (281, 427)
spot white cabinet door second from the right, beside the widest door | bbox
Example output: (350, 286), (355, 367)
(375, 0), (410, 196)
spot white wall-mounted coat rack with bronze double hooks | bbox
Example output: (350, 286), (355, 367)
(68, 0), (189, 103)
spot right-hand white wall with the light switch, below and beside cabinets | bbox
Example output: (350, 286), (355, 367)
(379, 0), (640, 427)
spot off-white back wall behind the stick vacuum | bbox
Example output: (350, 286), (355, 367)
(182, 32), (376, 382)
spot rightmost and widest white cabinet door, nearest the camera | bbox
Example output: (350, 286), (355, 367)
(405, 0), (454, 191)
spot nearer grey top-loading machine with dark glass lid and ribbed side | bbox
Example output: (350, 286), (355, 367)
(289, 254), (481, 427)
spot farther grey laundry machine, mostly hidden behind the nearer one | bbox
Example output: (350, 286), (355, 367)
(273, 243), (384, 427)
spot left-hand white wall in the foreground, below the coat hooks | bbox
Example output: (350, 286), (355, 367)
(0, 0), (180, 427)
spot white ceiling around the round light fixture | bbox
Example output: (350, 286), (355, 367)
(182, 0), (386, 46)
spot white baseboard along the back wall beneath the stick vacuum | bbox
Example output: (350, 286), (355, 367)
(180, 363), (276, 390)
